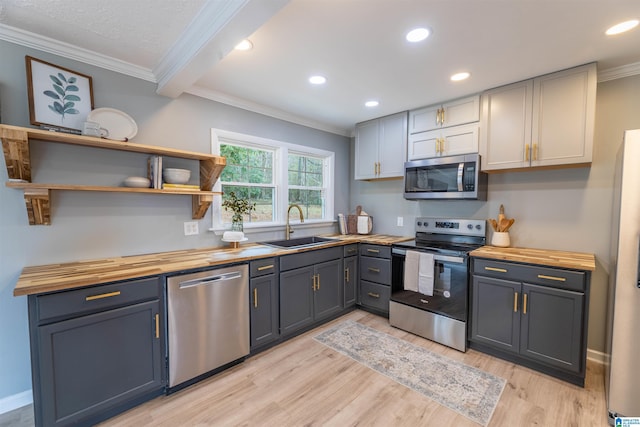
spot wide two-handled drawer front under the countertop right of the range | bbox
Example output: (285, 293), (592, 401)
(473, 259), (586, 292)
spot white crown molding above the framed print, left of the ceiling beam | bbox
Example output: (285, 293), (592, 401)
(0, 24), (156, 83)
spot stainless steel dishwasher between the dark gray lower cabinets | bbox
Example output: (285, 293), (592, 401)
(167, 264), (249, 388)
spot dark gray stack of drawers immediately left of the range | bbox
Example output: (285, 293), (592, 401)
(358, 244), (391, 317)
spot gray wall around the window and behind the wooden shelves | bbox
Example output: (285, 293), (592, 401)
(0, 41), (350, 406)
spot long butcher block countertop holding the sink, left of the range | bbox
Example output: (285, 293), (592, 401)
(13, 234), (413, 296)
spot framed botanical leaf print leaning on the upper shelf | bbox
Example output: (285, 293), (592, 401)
(25, 56), (93, 131)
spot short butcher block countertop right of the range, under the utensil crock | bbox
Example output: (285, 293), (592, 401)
(469, 246), (596, 271)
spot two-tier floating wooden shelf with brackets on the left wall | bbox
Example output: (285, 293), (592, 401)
(0, 125), (226, 225)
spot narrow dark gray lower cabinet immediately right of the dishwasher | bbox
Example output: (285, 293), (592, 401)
(249, 258), (280, 351)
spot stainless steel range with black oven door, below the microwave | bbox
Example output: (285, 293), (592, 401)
(389, 218), (486, 351)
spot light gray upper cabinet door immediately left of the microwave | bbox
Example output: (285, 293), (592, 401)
(378, 112), (407, 178)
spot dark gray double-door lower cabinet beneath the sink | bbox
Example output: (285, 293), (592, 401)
(280, 247), (343, 336)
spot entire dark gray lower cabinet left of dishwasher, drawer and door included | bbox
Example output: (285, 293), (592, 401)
(28, 277), (166, 426)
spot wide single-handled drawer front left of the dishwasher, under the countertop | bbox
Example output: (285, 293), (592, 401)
(35, 277), (161, 323)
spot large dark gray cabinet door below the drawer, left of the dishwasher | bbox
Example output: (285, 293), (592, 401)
(37, 300), (163, 425)
